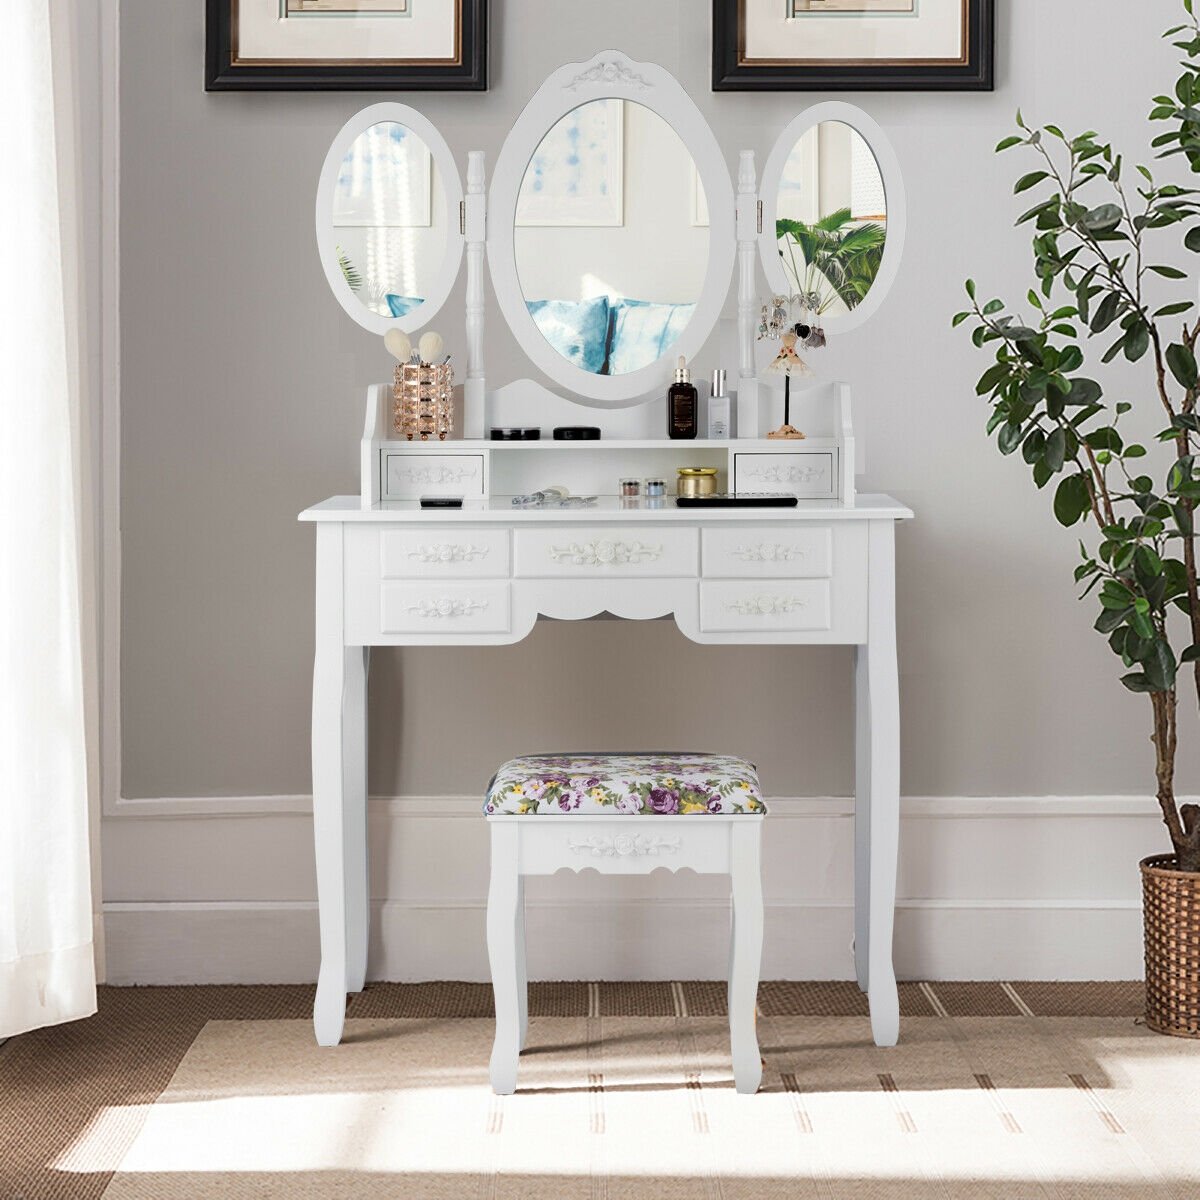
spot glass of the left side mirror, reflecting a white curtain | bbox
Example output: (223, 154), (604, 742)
(330, 121), (446, 317)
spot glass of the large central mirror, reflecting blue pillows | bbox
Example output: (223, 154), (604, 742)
(514, 100), (709, 376)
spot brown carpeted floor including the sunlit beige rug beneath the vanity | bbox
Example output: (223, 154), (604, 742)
(9, 983), (1200, 1200)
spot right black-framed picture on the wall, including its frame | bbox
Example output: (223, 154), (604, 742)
(713, 0), (996, 91)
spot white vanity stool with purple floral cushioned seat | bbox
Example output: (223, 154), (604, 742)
(484, 752), (767, 1096)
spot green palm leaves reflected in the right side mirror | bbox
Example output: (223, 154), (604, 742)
(775, 209), (888, 313)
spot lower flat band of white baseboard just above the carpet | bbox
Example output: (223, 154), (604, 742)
(106, 899), (1141, 984)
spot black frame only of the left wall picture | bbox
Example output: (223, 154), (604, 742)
(204, 0), (488, 91)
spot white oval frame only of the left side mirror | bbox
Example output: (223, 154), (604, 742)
(317, 101), (466, 336)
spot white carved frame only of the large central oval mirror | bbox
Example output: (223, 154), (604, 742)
(487, 50), (737, 408)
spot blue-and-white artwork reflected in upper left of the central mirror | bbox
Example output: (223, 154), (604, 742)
(517, 100), (625, 226)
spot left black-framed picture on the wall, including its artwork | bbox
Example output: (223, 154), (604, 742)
(204, 0), (488, 91)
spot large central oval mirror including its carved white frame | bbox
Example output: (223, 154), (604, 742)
(488, 52), (734, 407)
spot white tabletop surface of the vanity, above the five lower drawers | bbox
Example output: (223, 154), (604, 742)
(299, 494), (913, 524)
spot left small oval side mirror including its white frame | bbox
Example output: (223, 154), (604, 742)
(317, 103), (463, 334)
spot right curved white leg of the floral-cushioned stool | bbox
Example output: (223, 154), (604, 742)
(730, 820), (762, 1096)
